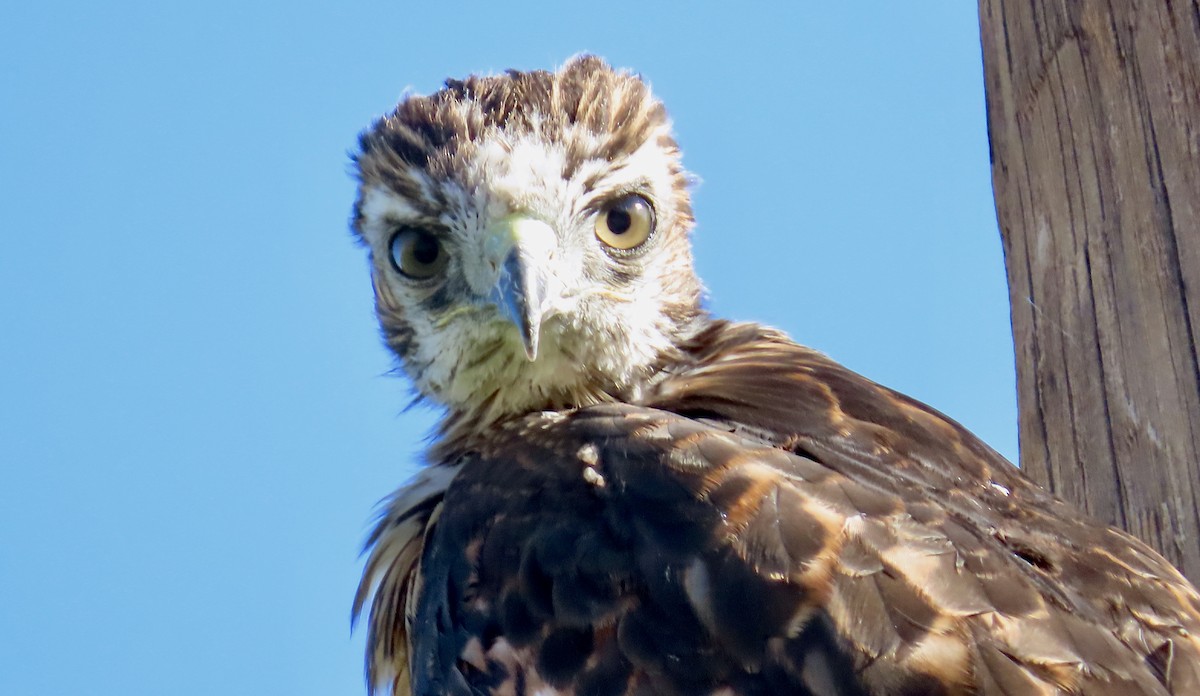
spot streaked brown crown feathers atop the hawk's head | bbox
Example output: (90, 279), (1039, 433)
(354, 55), (691, 234)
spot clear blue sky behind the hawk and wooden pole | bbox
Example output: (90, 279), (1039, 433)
(0, 0), (1016, 696)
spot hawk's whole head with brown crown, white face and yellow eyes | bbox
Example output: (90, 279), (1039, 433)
(354, 58), (700, 421)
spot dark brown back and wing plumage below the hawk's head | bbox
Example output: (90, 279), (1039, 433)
(360, 323), (1200, 696)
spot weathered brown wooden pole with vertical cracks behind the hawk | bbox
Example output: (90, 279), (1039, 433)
(979, 0), (1200, 582)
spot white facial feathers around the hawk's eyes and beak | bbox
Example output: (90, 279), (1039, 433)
(360, 102), (691, 421)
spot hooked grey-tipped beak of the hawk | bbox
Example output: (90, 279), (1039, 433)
(484, 215), (557, 361)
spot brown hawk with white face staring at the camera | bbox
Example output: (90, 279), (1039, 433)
(353, 56), (1200, 696)
